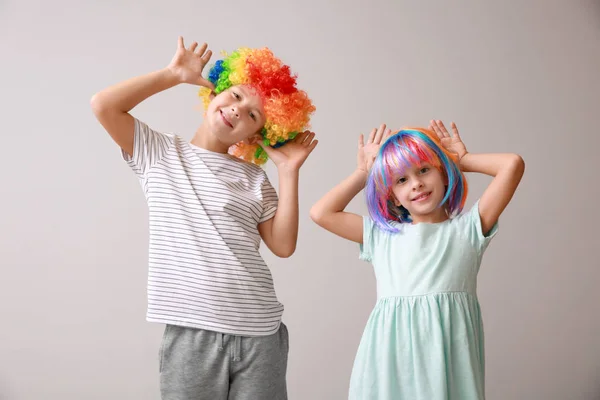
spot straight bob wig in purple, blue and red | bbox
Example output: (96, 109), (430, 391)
(365, 128), (468, 233)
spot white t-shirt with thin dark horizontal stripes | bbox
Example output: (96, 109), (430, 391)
(122, 119), (283, 336)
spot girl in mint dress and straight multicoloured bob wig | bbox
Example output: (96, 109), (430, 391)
(311, 121), (524, 400)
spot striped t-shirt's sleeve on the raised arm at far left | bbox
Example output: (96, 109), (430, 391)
(121, 118), (174, 178)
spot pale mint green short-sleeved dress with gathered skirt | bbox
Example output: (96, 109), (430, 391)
(349, 202), (498, 400)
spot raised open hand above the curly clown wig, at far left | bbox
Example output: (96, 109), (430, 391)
(167, 36), (214, 90)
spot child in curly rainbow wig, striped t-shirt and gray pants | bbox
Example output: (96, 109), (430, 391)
(92, 38), (317, 400)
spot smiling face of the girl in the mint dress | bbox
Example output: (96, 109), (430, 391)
(392, 163), (448, 223)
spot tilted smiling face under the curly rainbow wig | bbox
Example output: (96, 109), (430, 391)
(206, 85), (266, 146)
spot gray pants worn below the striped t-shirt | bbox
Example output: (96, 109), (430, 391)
(159, 323), (289, 400)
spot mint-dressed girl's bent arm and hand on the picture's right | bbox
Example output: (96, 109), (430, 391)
(430, 121), (525, 234)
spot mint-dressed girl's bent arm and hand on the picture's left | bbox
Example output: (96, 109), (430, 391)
(310, 125), (391, 244)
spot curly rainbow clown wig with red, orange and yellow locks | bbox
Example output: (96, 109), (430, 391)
(199, 48), (315, 164)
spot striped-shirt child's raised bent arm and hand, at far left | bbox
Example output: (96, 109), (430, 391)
(91, 37), (213, 156)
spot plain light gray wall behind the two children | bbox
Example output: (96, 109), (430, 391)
(0, 0), (600, 400)
